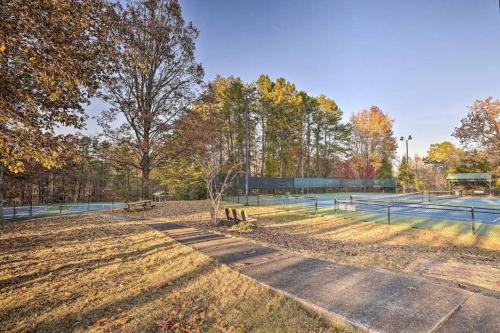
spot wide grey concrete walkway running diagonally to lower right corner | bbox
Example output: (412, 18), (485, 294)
(148, 223), (500, 332)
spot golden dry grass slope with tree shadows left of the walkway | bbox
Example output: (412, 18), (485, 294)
(0, 216), (340, 332)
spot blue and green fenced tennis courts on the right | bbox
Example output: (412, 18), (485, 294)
(226, 192), (500, 232)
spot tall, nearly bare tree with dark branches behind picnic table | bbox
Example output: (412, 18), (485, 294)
(99, 0), (203, 198)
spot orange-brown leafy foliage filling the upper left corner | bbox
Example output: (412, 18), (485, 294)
(0, 0), (114, 173)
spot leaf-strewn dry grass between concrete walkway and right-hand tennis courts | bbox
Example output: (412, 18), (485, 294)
(124, 201), (500, 296)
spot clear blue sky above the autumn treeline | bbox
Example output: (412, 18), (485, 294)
(87, 0), (500, 155)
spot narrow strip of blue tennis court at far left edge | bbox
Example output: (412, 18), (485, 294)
(3, 202), (125, 220)
